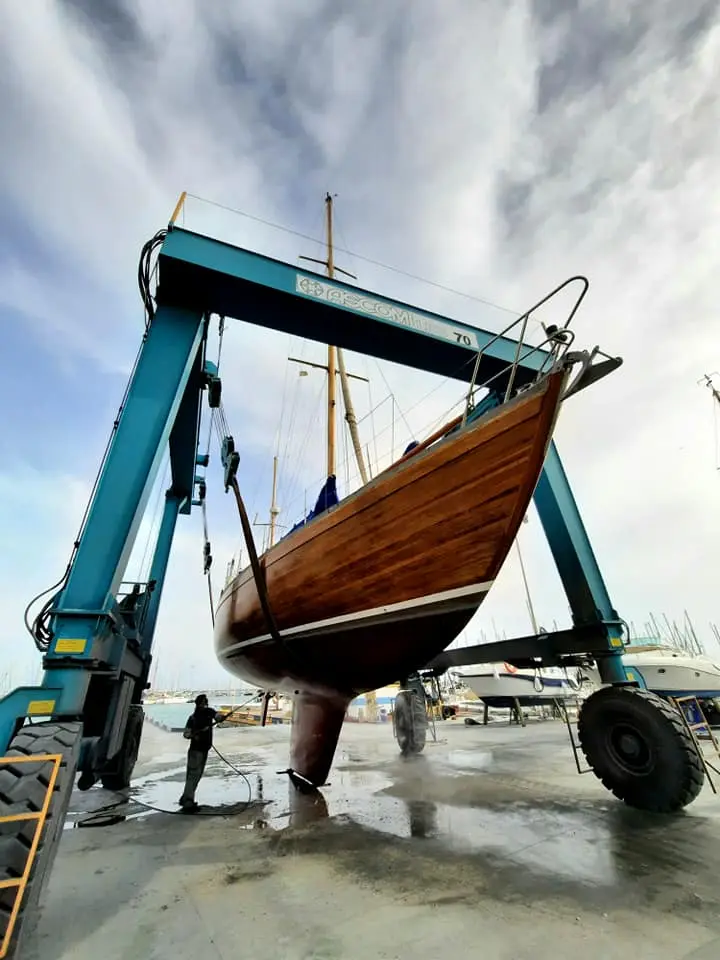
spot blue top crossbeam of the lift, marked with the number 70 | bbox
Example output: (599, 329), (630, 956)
(159, 227), (564, 387)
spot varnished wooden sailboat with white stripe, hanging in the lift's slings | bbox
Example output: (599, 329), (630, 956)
(215, 196), (569, 785)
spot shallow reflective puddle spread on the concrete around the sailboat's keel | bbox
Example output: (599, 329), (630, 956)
(60, 728), (715, 895)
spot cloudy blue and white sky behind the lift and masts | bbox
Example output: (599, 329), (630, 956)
(0, 0), (720, 688)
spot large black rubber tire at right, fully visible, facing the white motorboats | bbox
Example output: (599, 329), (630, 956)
(578, 687), (705, 813)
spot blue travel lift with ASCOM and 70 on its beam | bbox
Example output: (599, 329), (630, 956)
(0, 195), (704, 958)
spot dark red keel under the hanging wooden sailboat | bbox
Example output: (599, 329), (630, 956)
(290, 691), (350, 787)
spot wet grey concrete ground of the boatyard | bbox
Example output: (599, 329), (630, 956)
(23, 721), (720, 960)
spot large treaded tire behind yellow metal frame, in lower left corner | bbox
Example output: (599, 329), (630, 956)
(0, 722), (82, 958)
